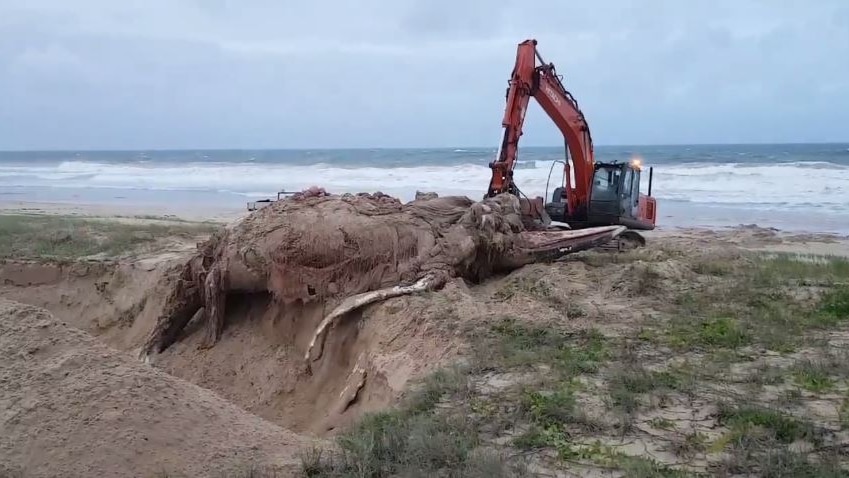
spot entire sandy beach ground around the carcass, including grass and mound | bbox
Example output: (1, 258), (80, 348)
(0, 195), (849, 476)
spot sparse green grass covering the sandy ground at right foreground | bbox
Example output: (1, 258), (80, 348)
(304, 251), (849, 478)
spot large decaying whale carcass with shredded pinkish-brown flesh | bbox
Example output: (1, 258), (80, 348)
(142, 191), (624, 362)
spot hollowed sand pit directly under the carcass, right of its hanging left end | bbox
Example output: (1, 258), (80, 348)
(151, 284), (444, 435)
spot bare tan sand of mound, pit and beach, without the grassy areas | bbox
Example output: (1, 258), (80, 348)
(0, 200), (849, 477)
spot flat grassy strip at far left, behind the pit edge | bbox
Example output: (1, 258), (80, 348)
(0, 215), (217, 260)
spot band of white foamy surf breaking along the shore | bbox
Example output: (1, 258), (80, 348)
(0, 161), (849, 212)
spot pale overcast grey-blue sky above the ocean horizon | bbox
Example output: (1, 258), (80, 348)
(0, 0), (849, 149)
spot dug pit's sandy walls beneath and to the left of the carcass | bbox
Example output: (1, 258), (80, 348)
(0, 254), (470, 435)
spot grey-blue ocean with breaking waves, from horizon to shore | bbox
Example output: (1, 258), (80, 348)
(0, 144), (849, 233)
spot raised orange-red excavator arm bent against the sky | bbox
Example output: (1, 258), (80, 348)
(487, 40), (594, 220)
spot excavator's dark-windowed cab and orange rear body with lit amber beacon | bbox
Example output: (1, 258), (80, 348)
(587, 160), (656, 230)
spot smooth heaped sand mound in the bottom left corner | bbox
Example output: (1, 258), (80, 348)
(0, 299), (314, 477)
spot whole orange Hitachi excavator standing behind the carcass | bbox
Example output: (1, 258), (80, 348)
(486, 39), (657, 250)
